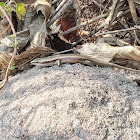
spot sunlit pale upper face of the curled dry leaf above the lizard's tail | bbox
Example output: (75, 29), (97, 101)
(78, 42), (140, 62)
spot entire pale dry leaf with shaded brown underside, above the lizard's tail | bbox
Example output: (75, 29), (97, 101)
(77, 42), (140, 69)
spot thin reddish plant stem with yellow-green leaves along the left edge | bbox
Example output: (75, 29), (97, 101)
(0, 0), (26, 89)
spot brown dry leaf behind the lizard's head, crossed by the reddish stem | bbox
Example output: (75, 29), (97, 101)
(0, 47), (55, 78)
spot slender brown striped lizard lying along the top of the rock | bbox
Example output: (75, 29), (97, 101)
(31, 54), (140, 72)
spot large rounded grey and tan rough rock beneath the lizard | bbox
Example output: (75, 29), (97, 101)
(0, 64), (140, 140)
